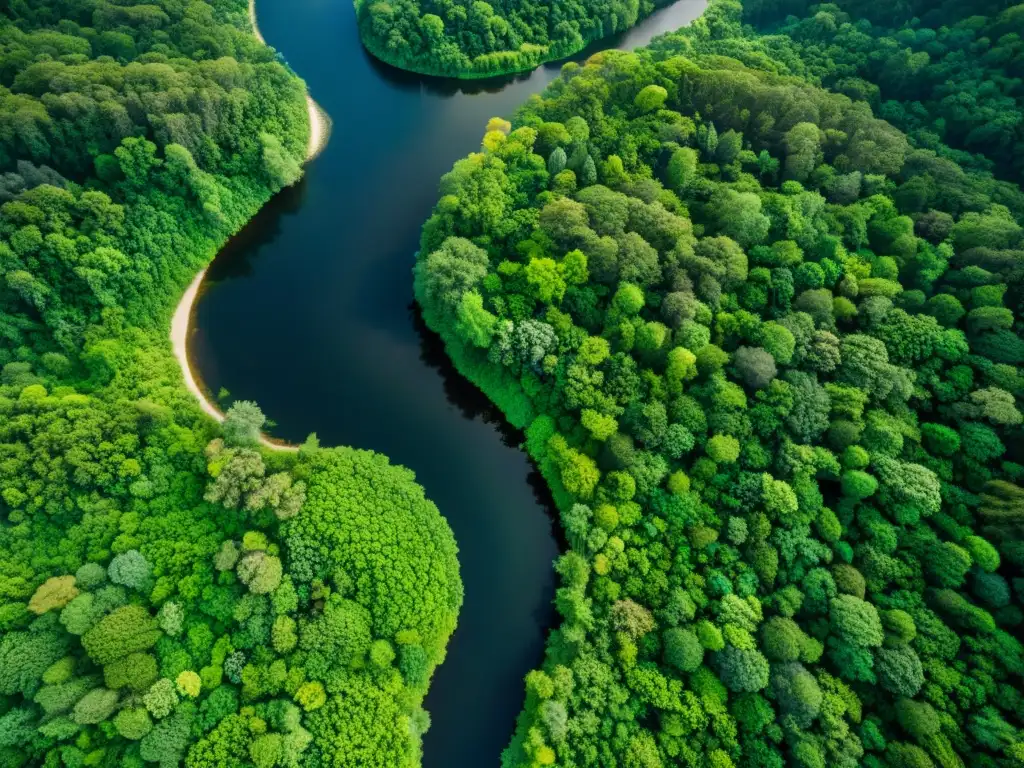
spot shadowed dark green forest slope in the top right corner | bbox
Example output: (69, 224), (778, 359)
(733, 0), (1024, 191)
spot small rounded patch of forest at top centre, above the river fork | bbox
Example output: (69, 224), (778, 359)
(354, 0), (669, 78)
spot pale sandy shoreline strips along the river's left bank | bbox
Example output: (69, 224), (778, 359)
(170, 0), (331, 451)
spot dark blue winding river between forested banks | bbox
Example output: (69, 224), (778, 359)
(191, 0), (705, 768)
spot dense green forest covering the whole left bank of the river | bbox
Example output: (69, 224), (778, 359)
(0, 0), (462, 768)
